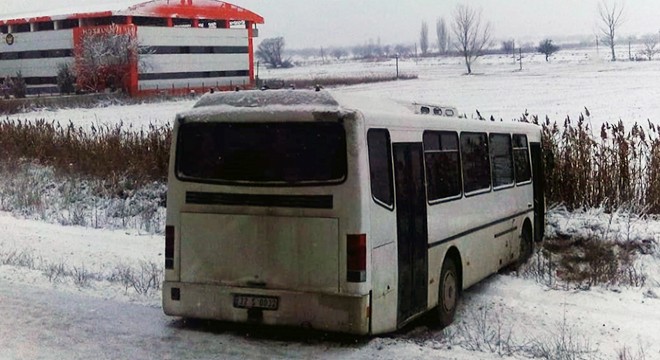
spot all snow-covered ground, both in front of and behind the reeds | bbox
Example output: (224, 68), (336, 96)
(0, 51), (660, 359)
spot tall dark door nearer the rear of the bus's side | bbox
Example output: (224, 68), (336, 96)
(393, 143), (428, 324)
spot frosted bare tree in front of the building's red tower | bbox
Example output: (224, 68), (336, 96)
(74, 24), (152, 91)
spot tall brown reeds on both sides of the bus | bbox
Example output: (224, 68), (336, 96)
(0, 109), (660, 214)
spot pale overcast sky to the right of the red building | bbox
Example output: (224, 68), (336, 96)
(228, 0), (660, 48)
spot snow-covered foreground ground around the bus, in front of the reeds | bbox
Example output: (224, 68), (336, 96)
(0, 208), (660, 359)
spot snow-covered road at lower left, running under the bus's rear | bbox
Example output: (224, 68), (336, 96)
(0, 276), (486, 360)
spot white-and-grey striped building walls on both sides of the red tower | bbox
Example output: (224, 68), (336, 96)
(0, 26), (250, 92)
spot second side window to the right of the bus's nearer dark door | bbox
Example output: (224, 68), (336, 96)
(461, 133), (490, 194)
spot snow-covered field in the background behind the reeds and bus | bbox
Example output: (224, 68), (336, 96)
(5, 49), (660, 128)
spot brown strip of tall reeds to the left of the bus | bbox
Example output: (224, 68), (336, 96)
(0, 119), (172, 190)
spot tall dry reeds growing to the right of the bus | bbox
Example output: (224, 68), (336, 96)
(521, 108), (660, 214)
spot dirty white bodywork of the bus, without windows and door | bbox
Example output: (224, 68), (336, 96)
(163, 91), (542, 334)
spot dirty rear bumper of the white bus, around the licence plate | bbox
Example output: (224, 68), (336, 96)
(163, 281), (371, 335)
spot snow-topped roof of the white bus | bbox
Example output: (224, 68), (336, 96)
(178, 89), (540, 140)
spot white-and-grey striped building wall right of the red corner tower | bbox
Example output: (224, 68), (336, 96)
(137, 27), (250, 91)
